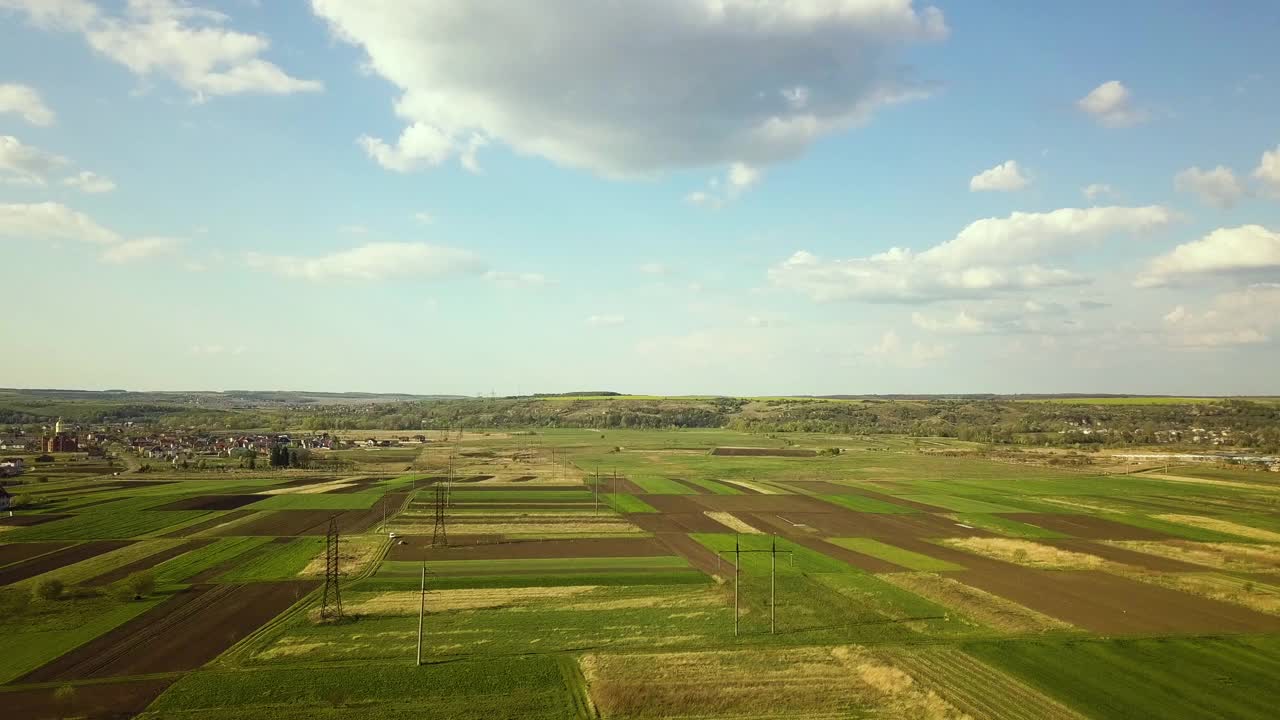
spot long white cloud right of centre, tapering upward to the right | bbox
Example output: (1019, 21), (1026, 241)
(769, 205), (1172, 302)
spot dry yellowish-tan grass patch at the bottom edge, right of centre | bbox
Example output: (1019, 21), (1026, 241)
(580, 646), (969, 720)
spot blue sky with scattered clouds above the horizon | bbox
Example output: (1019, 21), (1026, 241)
(0, 0), (1280, 395)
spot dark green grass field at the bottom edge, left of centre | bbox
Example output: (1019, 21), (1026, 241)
(141, 656), (575, 720)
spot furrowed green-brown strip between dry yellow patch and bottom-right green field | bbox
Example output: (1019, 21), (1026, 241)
(887, 646), (1084, 720)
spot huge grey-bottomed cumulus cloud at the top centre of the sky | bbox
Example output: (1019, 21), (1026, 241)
(311, 0), (947, 177)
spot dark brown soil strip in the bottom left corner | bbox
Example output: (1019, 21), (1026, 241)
(0, 678), (178, 720)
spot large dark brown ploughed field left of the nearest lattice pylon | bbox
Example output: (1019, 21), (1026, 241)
(20, 582), (319, 683)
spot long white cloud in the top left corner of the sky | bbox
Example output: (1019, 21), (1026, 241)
(0, 0), (323, 99)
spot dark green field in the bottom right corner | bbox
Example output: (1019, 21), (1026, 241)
(964, 637), (1280, 720)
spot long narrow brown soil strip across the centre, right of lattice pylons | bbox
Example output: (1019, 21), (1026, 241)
(387, 536), (669, 560)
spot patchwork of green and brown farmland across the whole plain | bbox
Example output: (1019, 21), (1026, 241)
(0, 425), (1280, 720)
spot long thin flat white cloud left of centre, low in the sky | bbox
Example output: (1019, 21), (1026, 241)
(246, 242), (484, 281)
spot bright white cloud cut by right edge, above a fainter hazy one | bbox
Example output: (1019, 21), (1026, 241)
(1135, 225), (1280, 287)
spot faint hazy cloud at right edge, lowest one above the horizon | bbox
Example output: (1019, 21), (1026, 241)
(1164, 283), (1280, 348)
